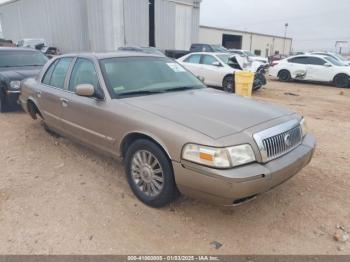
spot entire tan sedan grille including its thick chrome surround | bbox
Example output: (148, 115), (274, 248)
(254, 119), (302, 163)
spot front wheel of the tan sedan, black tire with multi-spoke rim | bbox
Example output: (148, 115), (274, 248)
(125, 139), (179, 208)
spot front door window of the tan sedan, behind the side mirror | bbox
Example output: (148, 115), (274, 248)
(68, 58), (99, 92)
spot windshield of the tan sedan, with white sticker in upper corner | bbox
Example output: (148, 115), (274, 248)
(100, 57), (205, 98)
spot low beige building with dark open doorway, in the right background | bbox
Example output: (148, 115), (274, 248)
(199, 26), (293, 57)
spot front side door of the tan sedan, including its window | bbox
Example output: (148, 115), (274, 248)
(58, 58), (115, 153)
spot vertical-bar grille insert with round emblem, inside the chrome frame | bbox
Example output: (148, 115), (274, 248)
(263, 126), (301, 160)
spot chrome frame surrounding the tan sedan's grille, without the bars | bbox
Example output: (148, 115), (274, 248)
(253, 119), (301, 163)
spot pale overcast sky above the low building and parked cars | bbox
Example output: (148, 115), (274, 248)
(201, 0), (350, 51)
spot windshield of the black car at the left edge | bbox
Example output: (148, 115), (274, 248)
(0, 51), (48, 67)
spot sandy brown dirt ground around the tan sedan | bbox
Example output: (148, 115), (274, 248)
(0, 81), (350, 254)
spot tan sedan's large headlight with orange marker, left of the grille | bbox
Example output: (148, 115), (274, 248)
(182, 144), (255, 168)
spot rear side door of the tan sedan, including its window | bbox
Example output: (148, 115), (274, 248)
(35, 57), (73, 130)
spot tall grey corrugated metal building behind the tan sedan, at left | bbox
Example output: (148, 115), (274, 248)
(0, 0), (201, 52)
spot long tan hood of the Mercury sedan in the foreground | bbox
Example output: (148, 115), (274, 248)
(125, 88), (293, 139)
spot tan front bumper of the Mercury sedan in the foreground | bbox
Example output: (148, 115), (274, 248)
(173, 135), (316, 206)
